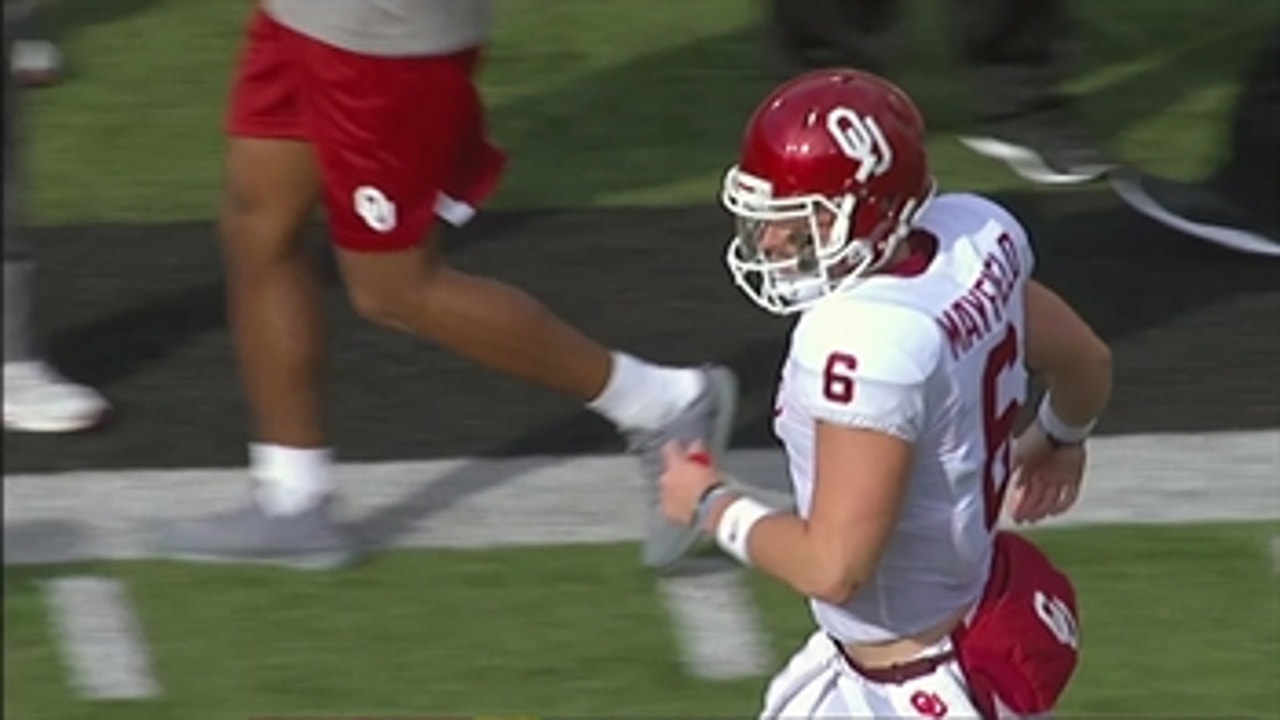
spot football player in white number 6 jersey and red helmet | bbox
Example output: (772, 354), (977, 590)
(662, 69), (1111, 717)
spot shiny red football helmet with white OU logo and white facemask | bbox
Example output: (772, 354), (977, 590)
(722, 69), (936, 315)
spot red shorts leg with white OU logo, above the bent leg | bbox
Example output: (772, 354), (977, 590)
(294, 41), (504, 252)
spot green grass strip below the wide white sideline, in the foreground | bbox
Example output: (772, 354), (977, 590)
(4, 523), (1280, 720)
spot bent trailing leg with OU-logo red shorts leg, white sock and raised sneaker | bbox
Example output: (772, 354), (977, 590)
(306, 42), (736, 565)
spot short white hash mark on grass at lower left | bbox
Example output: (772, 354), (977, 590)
(45, 577), (160, 700)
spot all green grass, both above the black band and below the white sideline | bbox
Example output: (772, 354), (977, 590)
(4, 0), (1280, 720)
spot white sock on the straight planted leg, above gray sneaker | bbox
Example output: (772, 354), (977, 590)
(248, 442), (333, 515)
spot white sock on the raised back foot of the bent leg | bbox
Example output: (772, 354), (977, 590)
(588, 352), (707, 430)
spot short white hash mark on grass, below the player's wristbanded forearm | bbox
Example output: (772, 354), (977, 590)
(660, 569), (772, 680)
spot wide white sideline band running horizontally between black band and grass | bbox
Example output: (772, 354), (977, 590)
(4, 430), (1280, 564)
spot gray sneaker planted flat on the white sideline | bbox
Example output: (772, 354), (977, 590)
(152, 489), (355, 570)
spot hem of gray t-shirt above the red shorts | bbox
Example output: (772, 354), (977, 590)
(264, 0), (492, 56)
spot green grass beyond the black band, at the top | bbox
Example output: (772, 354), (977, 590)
(27, 0), (1276, 224)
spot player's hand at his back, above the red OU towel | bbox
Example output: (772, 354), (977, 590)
(1006, 423), (1085, 523)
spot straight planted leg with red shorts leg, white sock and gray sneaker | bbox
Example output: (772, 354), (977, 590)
(156, 5), (348, 566)
